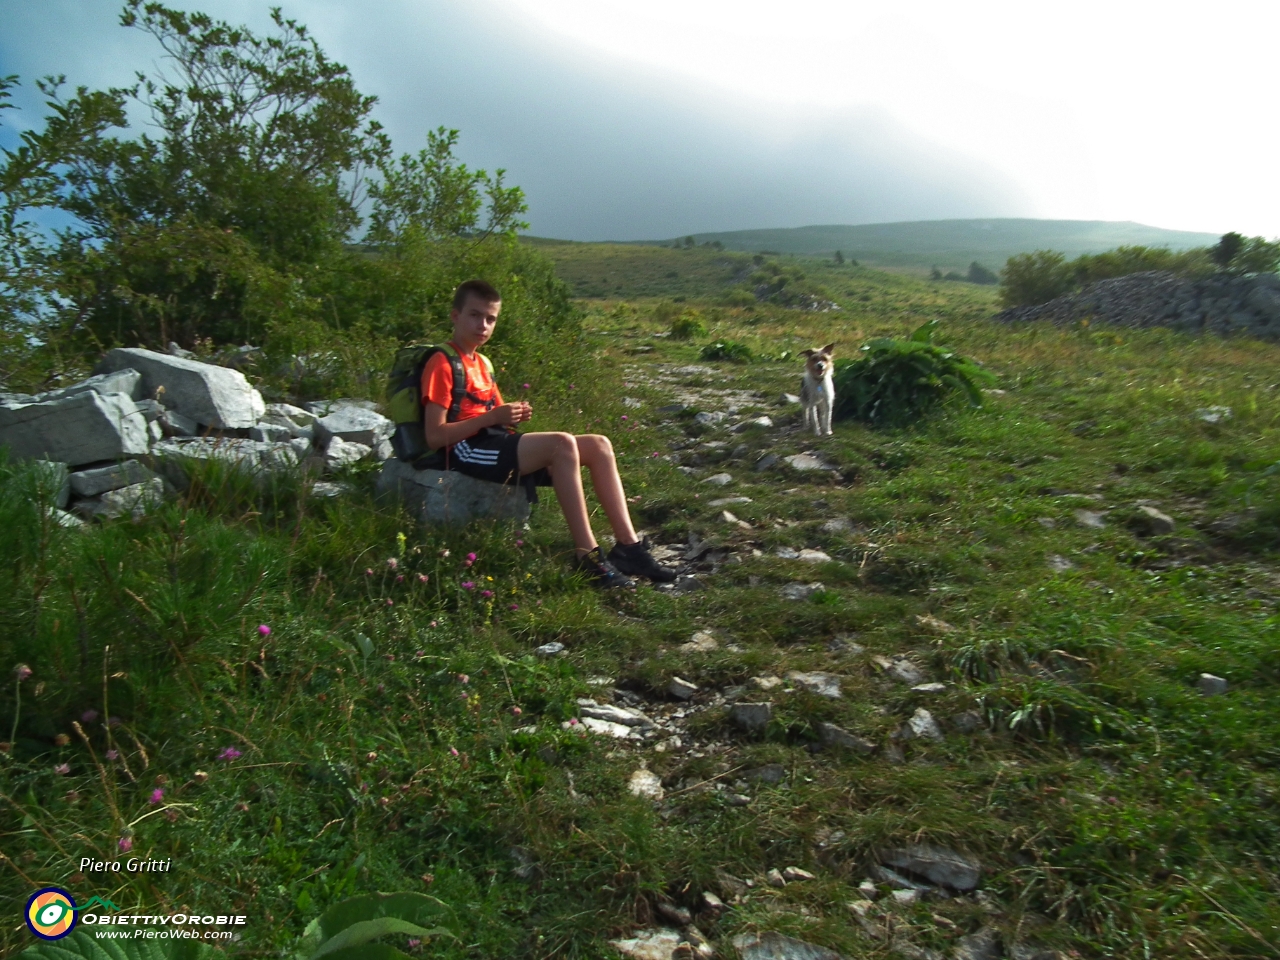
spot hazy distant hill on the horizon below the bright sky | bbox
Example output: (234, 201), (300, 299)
(654, 219), (1219, 273)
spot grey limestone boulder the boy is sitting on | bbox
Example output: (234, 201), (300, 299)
(378, 460), (529, 524)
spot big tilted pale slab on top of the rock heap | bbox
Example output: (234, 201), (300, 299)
(95, 347), (266, 429)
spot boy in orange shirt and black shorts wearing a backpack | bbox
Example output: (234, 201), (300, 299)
(422, 280), (676, 588)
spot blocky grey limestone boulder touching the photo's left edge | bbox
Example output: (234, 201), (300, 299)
(0, 390), (151, 466)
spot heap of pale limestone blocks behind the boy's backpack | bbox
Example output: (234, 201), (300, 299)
(0, 348), (394, 522)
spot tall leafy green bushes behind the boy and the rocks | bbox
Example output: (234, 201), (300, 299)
(0, 0), (579, 397)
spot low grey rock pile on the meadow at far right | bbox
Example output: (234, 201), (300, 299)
(996, 270), (1280, 340)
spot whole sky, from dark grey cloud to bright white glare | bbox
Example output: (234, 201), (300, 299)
(0, 0), (1280, 239)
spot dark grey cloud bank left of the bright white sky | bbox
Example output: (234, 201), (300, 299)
(0, 0), (1032, 239)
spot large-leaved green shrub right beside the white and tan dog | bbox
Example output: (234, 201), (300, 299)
(835, 320), (996, 426)
